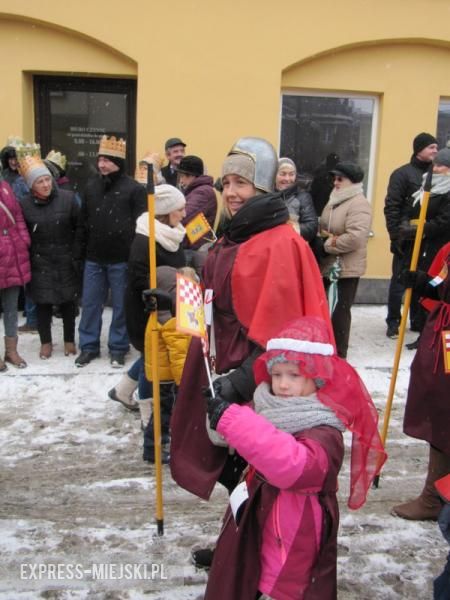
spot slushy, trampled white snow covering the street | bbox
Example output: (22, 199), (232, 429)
(0, 306), (448, 600)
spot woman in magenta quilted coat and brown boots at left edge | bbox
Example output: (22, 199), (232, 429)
(0, 181), (31, 371)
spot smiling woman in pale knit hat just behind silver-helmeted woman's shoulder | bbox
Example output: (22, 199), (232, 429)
(275, 158), (318, 242)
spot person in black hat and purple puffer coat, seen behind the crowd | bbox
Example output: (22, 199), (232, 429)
(177, 156), (217, 243)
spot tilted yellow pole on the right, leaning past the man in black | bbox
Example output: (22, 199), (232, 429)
(373, 167), (433, 488)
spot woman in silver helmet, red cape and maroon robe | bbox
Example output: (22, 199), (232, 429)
(170, 137), (333, 540)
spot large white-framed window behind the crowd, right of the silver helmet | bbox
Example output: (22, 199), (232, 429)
(280, 93), (378, 193)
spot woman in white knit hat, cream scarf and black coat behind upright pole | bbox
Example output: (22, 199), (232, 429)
(123, 183), (186, 462)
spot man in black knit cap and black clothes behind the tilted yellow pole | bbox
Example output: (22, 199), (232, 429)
(384, 132), (438, 338)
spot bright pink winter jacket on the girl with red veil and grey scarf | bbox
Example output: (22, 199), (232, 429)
(217, 404), (328, 599)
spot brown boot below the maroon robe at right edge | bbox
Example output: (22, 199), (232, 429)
(391, 446), (450, 521)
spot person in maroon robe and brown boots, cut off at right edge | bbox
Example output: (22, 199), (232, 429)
(392, 242), (450, 521)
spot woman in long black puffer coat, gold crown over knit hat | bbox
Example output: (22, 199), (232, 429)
(19, 155), (81, 359)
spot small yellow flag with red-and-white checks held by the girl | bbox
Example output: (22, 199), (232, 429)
(176, 273), (206, 337)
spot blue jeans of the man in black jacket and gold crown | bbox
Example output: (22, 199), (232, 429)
(79, 261), (130, 354)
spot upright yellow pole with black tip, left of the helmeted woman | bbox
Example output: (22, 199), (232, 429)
(144, 163), (164, 535)
